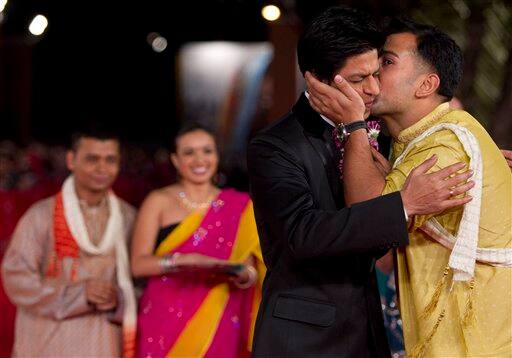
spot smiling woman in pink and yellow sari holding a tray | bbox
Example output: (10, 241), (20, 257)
(131, 125), (264, 358)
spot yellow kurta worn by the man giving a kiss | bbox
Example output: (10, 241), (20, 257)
(384, 103), (512, 357)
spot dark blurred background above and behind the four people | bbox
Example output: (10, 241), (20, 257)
(0, 0), (512, 146)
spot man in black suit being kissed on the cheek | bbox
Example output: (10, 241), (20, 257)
(248, 8), (469, 357)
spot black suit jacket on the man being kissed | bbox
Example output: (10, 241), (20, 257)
(248, 96), (408, 357)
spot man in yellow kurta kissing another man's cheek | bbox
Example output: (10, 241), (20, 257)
(308, 20), (512, 357)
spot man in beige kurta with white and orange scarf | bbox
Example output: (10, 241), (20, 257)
(2, 130), (135, 357)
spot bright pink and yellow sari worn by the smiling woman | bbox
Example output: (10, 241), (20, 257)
(137, 190), (263, 357)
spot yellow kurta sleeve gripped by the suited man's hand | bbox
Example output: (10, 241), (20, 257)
(382, 130), (469, 230)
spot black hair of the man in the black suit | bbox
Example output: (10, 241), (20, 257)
(297, 6), (384, 81)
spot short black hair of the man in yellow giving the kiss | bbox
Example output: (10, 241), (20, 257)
(385, 18), (464, 101)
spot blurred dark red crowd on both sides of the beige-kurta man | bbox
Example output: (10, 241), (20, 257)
(0, 141), (175, 246)
